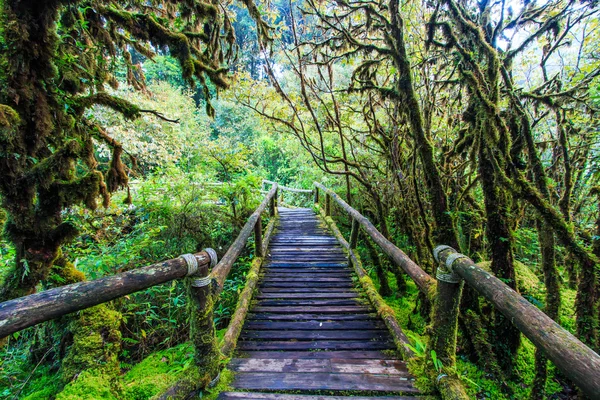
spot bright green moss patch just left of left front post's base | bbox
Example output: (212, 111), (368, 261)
(121, 343), (194, 400)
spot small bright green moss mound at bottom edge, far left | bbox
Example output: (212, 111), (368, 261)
(56, 370), (119, 400)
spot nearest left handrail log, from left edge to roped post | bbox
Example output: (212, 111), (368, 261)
(0, 251), (211, 338)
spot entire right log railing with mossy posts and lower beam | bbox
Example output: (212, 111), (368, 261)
(314, 182), (600, 399)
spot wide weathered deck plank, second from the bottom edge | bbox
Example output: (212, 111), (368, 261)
(231, 372), (418, 393)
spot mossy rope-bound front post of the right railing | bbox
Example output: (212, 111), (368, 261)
(430, 246), (469, 399)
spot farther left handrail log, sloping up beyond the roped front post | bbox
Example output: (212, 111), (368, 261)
(210, 183), (278, 294)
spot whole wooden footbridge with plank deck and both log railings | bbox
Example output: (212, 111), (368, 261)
(0, 182), (600, 400)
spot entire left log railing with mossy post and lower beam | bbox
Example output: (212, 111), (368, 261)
(0, 183), (277, 399)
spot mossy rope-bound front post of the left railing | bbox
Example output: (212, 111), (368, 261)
(186, 249), (221, 388)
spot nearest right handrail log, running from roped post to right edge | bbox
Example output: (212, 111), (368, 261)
(438, 248), (600, 399)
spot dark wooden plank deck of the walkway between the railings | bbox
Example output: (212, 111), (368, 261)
(219, 208), (417, 400)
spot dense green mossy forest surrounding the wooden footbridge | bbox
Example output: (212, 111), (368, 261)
(0, 0), (600, 399)
